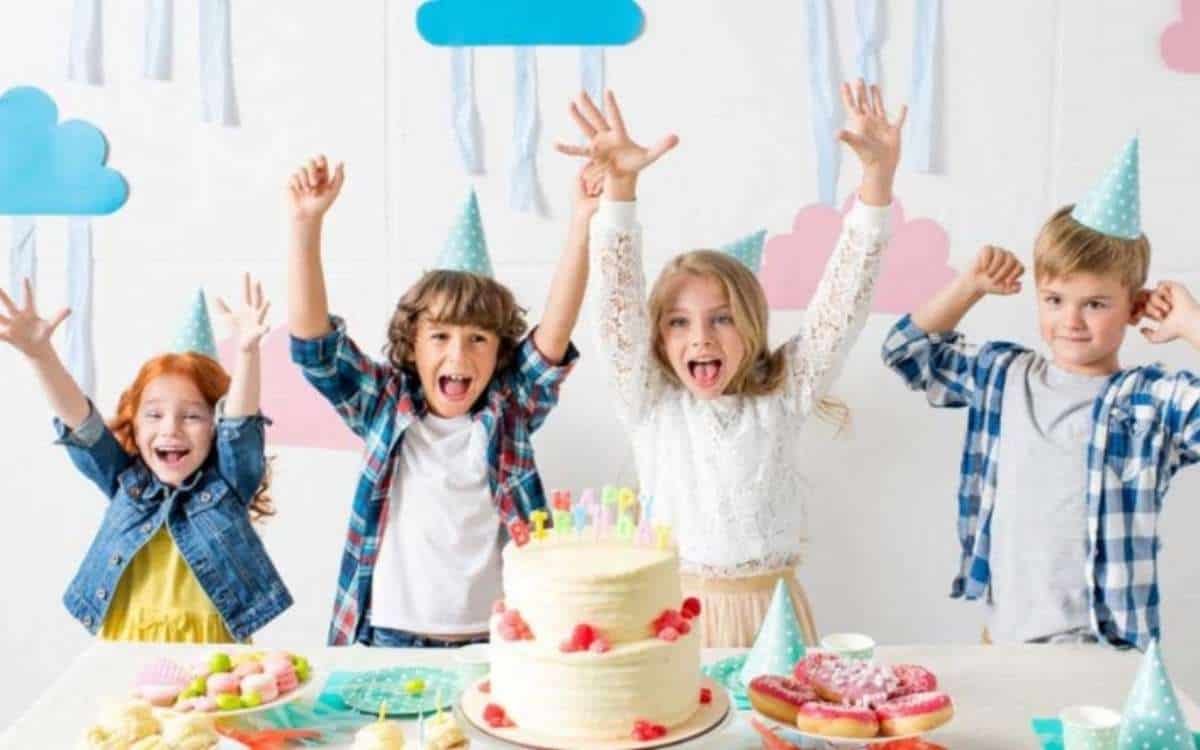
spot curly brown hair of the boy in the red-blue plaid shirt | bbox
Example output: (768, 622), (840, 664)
(384, 270), (529, 373)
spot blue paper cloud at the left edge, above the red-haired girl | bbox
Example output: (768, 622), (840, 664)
(0, 86), (130, 216)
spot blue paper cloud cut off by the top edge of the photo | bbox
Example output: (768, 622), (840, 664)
(416, 0), (646, 47)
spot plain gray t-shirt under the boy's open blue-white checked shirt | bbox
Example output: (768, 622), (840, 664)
(986, 354), (1109, 643)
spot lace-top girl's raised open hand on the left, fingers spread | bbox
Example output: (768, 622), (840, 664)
(556, 91), (679, 199)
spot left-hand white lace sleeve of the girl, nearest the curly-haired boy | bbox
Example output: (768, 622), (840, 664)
(590, 203), (662, 425)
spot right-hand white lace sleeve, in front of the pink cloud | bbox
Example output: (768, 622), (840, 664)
(785, 203), (890, 415)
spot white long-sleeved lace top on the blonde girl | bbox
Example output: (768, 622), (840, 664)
(590, 202), (888, 577)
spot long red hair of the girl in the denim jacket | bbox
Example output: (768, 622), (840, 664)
(108, 352), (275, 521)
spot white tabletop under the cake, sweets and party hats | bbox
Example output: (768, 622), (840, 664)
(0, 641), (1200, 750)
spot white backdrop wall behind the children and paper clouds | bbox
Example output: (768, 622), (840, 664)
(0, 0), (1200, 722)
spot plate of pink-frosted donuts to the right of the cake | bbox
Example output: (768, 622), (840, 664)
(746, 653), (954, 746)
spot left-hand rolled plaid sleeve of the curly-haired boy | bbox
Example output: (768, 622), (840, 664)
(292, 316), (395, 438)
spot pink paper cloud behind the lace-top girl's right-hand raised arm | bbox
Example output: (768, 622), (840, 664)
(758, 195), (954, 314)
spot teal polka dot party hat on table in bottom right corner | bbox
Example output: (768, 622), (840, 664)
(1117, 641), (1195, 750)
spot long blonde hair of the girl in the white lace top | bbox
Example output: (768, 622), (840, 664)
(649, 250), (850, 431)
